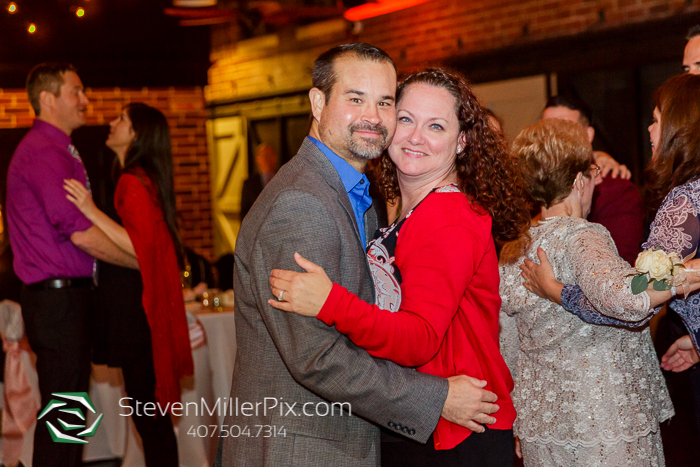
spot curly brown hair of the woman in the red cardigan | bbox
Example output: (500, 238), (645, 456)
(376, 68), (530, 242)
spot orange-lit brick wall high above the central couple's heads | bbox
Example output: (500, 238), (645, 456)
(205, 0), (700, 102)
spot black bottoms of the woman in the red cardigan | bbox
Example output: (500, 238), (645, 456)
(382, 428), (515, 467)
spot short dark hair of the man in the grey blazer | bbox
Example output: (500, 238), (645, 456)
(311, 42), (396, 102)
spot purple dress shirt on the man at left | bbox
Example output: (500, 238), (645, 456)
(7, 119), (93, 284)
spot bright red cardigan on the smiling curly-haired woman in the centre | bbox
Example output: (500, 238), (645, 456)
(318, 193), (515, 449)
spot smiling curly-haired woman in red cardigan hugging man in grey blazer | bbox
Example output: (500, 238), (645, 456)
(270, 69), (529, 467)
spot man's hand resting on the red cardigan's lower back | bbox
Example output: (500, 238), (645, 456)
(442, 375), (500, 433)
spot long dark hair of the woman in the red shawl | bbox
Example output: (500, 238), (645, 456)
(122, 102), (185, 269)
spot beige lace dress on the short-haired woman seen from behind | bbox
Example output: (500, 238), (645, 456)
(500, 217), (674, 467)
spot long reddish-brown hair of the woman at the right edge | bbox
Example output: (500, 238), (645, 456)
(644, 73), (700, 211)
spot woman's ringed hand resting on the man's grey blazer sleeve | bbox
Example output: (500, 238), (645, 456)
(267, 253), (333, 316)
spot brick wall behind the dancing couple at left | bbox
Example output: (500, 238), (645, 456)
(0, 87), (213, 259)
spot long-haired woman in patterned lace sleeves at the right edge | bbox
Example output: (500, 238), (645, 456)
(523, 74), (700, 371)
